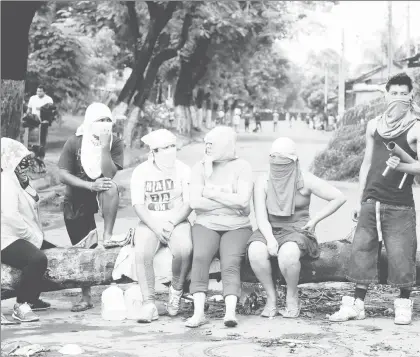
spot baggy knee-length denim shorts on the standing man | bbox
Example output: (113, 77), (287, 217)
(347, 200), (417, 288)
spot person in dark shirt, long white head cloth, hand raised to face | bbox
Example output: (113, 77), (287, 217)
(58, 103), (124, 312)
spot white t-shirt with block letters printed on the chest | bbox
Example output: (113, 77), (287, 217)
(131, 160), (191, 219)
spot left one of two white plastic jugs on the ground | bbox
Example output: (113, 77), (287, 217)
(101, 283), (127, 321)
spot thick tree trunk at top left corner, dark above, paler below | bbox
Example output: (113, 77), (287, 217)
(1, 1), (43, 140)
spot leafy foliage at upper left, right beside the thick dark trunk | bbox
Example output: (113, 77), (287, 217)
(26, 1), (121, 112)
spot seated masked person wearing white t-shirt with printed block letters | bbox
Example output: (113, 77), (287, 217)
(131, 129), (192, 323)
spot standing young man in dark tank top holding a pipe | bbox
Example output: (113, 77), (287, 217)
(330, 73), (420, 325)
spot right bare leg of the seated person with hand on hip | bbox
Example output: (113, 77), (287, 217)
(277, 242), (301, 309)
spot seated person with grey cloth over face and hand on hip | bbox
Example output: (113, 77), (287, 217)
(248, 137), (346, 318)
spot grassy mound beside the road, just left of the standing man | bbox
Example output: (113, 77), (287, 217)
(311, 124), (366, 181)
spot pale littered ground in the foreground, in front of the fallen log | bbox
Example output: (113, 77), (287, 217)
(2, 283), (420, 357)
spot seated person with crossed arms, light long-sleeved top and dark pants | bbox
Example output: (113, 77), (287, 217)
(186, 126), (253, 327)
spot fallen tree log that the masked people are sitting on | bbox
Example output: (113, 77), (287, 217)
(1, 240), (420, 299)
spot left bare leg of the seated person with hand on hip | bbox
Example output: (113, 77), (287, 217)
(248, 241), (277, 317)
